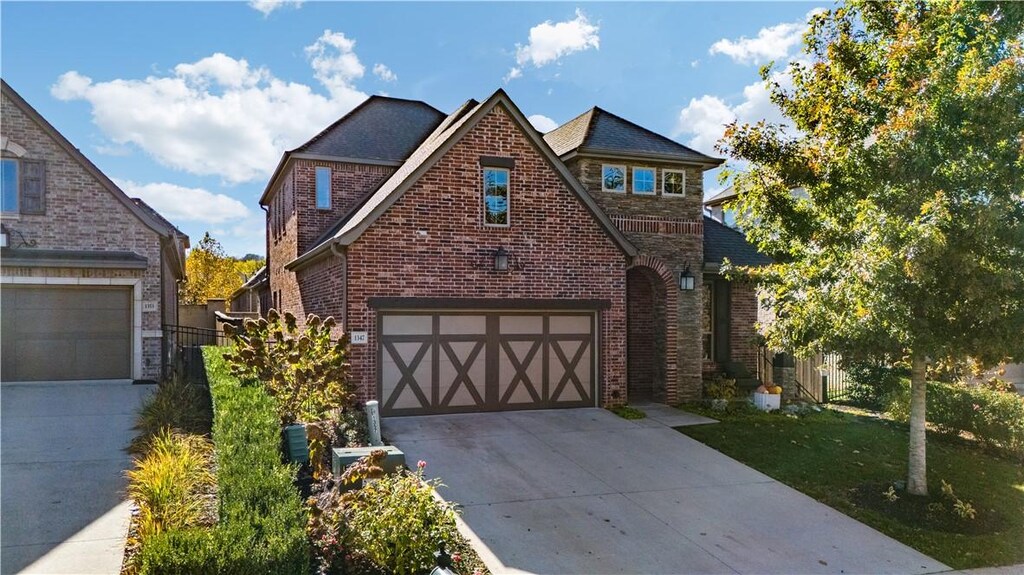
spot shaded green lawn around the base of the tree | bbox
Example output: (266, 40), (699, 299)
(679, 405), (1024, 569)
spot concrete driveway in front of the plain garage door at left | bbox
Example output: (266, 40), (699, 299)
(0, 382), (154, 574)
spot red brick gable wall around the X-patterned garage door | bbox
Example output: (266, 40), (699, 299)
(347, 106), (626, 405)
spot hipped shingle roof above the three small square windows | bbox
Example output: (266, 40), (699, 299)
(544, 106), (724, 166)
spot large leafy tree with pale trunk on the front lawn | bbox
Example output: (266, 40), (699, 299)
(720, 0), (1024, 494)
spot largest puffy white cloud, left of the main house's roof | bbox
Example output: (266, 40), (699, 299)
(50, 30), (367, 183)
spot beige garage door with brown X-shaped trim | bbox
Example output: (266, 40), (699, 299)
(378, 311), (597, 415)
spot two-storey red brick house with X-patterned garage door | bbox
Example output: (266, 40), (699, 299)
(260, 90), (761, 414)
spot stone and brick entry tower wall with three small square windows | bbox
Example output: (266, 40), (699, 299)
(567, 157), (703, 403)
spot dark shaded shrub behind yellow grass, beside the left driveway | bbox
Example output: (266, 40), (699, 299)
(128, 378), (213, 454)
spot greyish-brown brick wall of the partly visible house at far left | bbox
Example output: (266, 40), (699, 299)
(0, 91), (165, 379)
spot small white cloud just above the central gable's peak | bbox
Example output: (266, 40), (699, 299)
(506, 9), (601, 82)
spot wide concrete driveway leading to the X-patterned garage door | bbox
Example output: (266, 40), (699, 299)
(384, 409), (949, 574)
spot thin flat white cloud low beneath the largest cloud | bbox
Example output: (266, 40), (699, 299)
(114, 179), (250, 224)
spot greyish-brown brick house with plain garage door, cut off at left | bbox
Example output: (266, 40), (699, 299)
(0, 82), (188, 382)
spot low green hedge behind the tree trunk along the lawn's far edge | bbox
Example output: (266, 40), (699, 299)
(886, 380), (1024, 458)
